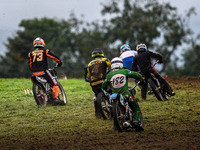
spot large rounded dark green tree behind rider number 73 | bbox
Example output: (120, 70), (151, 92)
(1, 18), (75, 77)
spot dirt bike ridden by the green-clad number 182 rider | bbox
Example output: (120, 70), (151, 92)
(110, 93), (143, 132)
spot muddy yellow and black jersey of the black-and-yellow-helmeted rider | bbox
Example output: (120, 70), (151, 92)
(86, 58), (111, 86)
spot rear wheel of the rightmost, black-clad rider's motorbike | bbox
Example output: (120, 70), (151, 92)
(147, 78), (164, 101)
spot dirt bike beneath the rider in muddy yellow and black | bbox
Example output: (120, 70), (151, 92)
(97, 88), (112, 119)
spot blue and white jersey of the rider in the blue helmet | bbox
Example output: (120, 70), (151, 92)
(120, 50), (137, 70)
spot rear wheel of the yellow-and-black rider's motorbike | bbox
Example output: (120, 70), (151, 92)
(97, 92), (112, 119)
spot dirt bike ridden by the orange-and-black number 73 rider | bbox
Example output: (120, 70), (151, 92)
(31, 64), (67, 106)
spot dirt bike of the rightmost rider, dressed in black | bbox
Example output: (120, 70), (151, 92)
(145, 61), (168, 101)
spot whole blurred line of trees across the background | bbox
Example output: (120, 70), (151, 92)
(0, 0), (200, 78)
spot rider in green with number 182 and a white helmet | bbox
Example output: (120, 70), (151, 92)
(102, 57), (144, 131)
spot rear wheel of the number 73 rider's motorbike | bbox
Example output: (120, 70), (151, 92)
(32, 84), (48, 106)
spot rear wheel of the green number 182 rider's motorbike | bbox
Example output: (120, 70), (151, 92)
(112, 100), (126, 132)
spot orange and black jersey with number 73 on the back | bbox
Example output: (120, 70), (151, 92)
(28, 48), (62, 72)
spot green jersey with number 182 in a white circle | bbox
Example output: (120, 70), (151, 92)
(102, 68), (143, 95)
